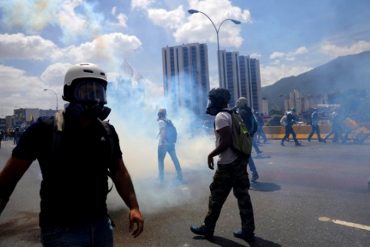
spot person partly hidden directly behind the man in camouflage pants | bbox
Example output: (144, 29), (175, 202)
(236, 97), (262, 182)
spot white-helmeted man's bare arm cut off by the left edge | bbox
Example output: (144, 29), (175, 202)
(0, 157), (32, 215)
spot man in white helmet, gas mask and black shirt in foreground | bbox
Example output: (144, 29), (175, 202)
(0, 63), (144, 247)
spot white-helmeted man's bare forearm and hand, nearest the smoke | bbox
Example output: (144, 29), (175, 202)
(112, 159), (144, 238)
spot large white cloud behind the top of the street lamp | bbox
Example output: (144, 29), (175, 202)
(147, 0), (251, 47)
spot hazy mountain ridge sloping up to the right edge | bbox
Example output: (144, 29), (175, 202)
(262, 50), (370, 109)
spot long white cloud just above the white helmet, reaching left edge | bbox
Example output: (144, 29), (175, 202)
(0, 33), (142, 65)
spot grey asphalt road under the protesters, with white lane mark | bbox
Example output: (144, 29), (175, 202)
(0, 141), (370, 247)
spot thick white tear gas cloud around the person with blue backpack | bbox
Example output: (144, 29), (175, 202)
(107, 72), (214, 212)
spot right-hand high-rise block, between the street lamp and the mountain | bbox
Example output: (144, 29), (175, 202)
(220, 51), (262, 111)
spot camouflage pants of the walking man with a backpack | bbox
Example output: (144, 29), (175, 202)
(204, 158), (254, 234)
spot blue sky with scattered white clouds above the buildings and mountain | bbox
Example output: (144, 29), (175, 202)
(0, 0), (370, 117)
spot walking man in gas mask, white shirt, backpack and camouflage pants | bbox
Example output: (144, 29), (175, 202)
(190, 88), (255, 243)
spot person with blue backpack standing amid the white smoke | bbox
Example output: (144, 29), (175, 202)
(157, 108), (183, 183)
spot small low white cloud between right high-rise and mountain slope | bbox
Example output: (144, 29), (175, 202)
(261, 64), (312, 86)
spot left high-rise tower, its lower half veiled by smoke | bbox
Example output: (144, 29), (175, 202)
(162, 43), (209, 115)
